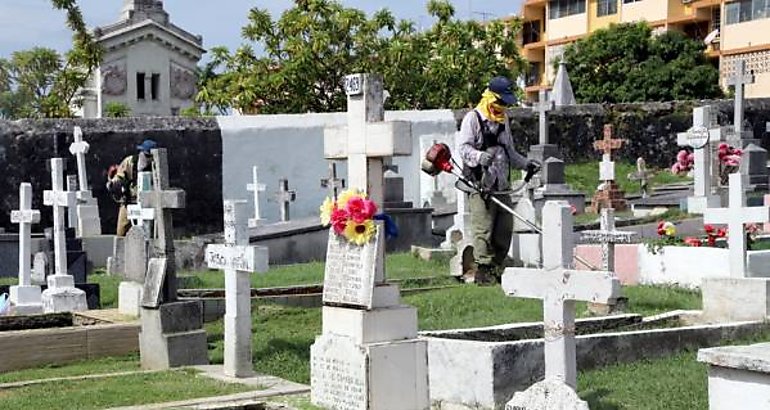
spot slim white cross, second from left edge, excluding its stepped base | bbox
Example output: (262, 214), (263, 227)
(43, 158), (76, 276)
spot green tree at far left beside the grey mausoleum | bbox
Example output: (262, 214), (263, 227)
(0, 0), (102, 118)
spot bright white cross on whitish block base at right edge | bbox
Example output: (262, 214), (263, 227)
(701, 172), (770, 321)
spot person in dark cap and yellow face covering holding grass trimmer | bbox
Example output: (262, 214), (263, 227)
(458, 77), (537, 284)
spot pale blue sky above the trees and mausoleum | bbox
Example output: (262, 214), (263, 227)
(0, 0), (521, 57)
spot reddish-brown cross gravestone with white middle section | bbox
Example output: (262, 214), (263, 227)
(591, 124), (628, 213)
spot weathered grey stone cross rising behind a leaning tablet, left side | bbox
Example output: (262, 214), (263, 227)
(139, 148), (185, 303)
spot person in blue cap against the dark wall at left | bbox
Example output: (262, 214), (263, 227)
(107, 139), (158, 236)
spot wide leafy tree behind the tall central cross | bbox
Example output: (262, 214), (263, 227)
(197, 0), (523, 113)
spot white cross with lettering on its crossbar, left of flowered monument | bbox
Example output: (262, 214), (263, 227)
(206, 201), (267, 377)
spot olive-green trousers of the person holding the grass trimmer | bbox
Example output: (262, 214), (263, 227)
(469, 193), (513, 267)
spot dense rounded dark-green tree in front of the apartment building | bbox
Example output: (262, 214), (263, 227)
(563, 23), (723, 103)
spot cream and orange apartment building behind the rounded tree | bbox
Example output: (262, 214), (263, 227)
(519, 0), (770, 100)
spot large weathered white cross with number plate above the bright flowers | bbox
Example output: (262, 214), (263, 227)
(324, 74), (412, 209)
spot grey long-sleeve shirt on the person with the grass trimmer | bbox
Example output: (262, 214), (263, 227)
(460, 109), (527, 191)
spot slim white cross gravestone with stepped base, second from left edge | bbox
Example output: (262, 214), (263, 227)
(42, 158), (88, 313)
